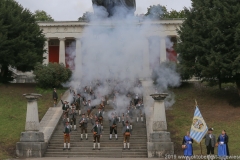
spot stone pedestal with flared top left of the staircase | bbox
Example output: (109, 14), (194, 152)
(16, 93), (47, 157)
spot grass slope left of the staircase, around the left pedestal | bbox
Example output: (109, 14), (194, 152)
(0, 84), (66, 159)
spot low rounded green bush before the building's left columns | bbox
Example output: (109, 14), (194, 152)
(33, 63), (72, 88)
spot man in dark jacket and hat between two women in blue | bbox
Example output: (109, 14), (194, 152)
(204, 128), (216, 160)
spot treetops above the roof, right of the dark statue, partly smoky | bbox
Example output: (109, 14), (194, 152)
(145, 4), (186, 19)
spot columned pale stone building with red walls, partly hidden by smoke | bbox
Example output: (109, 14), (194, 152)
(39, 19), (183, 69)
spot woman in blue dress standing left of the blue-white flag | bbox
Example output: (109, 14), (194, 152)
(182, 131), (193, 160)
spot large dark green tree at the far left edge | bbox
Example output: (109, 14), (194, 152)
(0, 0), (45, 83)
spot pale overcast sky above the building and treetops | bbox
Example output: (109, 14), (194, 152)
(16, 0), (191, 21)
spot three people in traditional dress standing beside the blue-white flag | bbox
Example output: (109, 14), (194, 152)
(182, 128), (230, 160)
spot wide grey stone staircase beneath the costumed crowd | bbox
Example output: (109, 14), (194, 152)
(45, 105), (147, 158)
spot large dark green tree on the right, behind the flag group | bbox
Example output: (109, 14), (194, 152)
(177, 0), (240, 95)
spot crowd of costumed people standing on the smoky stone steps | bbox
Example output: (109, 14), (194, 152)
(53, 81), (144, 150)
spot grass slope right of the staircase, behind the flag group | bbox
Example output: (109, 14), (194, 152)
(166, 83), (240, 155)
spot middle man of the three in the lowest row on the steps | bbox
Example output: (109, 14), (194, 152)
(91, 120), (102, 150)
